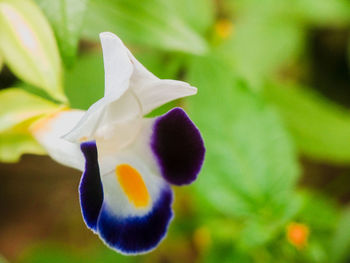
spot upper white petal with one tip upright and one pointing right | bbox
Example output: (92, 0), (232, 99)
(100, 32), (197, 115)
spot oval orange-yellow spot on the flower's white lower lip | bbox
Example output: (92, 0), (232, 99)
(115, 164), (151, 208)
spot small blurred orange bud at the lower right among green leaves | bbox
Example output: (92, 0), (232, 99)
(287, 222), (310, 249)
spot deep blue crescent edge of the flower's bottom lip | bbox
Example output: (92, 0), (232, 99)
(97, 186), (173, 254)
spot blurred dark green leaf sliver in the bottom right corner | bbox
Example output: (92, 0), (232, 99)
(331, 208), (350, 263)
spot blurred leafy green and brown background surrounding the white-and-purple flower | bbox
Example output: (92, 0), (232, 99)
(0, 0), (350, 263)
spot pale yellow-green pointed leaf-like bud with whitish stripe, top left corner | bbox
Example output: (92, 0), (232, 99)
(0, 0), (66, 101)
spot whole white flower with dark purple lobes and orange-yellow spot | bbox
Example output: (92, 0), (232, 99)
(32, 33), (205, 254)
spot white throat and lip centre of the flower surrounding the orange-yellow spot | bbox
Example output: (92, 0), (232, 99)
(96, 119), (167, 217)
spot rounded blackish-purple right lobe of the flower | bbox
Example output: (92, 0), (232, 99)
(151, 108), (205, 185)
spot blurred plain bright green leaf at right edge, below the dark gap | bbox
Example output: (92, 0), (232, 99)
(264, 84), (350, 164)
